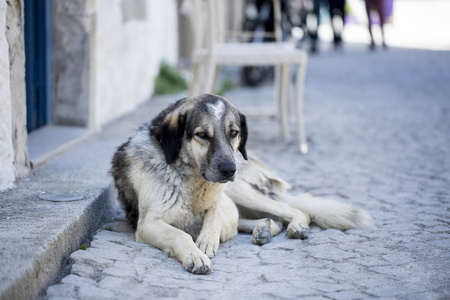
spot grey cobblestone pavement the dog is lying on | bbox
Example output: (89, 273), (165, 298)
(46, 46), (450, 299)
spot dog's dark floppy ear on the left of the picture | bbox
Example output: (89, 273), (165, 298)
(150, 99), (186, 165)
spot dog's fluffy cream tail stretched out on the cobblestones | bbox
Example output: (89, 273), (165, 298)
(284, 193), (373, 230)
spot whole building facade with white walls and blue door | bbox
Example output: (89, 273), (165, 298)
(0, 0), (178, 190)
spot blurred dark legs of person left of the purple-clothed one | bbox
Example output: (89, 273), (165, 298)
(307, 0), (345, 53)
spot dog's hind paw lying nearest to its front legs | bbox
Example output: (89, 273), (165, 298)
(238, 218), (283, 245)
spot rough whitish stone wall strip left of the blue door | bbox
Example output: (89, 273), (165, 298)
(0, 0), (28, 190)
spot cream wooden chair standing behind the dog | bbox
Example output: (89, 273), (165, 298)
(190, 0), (308, 154)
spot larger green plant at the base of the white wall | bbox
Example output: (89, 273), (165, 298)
(155, 61), (188, 94)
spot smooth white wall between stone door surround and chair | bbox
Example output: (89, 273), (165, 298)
(93, 0), (178, 128)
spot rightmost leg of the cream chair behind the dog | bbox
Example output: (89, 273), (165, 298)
(296, 56), (308, 154)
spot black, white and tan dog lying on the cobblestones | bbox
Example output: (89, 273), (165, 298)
(111, 94), (371, 274)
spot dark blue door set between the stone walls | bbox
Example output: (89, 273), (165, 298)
(24, 0), (52, 131)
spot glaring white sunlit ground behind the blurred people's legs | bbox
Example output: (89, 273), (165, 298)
(319, 0), (450, 50)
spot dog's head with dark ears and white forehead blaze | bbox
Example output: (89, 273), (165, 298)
(150, 94), (248, 182)
